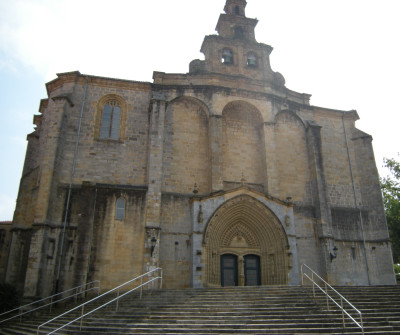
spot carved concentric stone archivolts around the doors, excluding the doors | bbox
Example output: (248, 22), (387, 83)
(203, 195), (290, 285)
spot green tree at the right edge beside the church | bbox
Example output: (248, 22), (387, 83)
(381, 158), (400, 263)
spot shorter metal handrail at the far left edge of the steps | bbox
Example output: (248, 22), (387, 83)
(0, 280), (100, 323)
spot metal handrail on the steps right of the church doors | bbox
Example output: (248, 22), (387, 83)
(301, 264), (364, 335)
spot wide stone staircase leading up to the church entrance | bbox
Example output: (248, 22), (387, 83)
(0, 286), (400, 335)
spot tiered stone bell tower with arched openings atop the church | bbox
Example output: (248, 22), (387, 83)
(189, 0), (284, 86)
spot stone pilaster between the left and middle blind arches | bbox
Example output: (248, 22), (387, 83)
(210, 115), (224, 192)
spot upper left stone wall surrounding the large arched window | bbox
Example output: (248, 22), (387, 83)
(54, 79), (150, 189)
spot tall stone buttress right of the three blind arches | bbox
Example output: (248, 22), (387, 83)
(306, 121), (335, 279)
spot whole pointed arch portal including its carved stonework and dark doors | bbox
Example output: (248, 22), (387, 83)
(203, 195), (290, 286)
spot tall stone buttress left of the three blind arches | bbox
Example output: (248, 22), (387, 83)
(145, 92), (166, 271)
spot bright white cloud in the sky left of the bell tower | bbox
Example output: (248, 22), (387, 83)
(0, 0), (223, 81)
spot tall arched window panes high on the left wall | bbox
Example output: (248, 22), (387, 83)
(100, 100), (121, 140)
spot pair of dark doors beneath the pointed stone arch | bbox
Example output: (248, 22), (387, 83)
(221, 254), (261, 286)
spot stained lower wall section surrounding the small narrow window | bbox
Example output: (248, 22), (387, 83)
(88, 188), (145, 289)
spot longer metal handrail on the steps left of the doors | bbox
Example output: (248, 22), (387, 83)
(37, 268), (162, 335)
